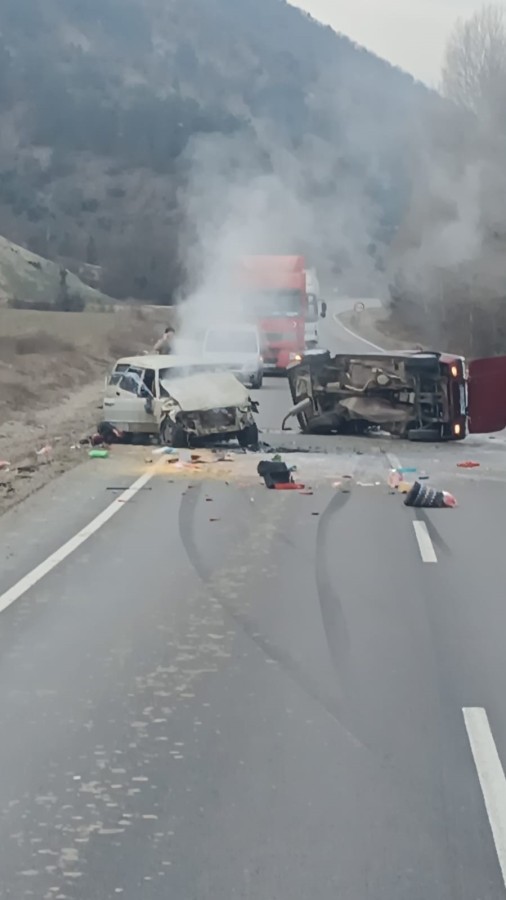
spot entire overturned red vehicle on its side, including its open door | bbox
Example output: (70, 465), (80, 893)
(283, 351), (506, 441)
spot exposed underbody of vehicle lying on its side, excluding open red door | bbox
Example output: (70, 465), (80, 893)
(283, 351), (465, 440)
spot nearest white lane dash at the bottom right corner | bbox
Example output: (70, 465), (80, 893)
(462, 706), (506, 886)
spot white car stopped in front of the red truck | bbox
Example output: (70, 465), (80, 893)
(202, 325), (264, 388)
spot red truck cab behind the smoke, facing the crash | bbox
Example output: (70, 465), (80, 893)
(239, 256), (307, 372)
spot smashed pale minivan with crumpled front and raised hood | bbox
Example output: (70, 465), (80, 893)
(103, 355), (258, 447)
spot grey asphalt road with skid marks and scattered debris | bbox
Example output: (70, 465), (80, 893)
(0, 306), (506, 900)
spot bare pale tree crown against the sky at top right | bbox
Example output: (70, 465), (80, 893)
(442, 3), (506, 118)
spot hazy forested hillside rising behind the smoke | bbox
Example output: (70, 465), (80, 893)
(0, 0), (427, 302)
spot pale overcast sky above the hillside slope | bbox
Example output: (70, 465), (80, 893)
(291, 0), (483, 87)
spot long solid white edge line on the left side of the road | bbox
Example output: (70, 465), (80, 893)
(0, 471), (155, 613)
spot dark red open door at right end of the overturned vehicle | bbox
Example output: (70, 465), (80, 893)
(467, 356), (506, 434)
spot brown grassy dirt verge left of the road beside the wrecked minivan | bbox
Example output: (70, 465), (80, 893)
(0, 308), (168, 511)
